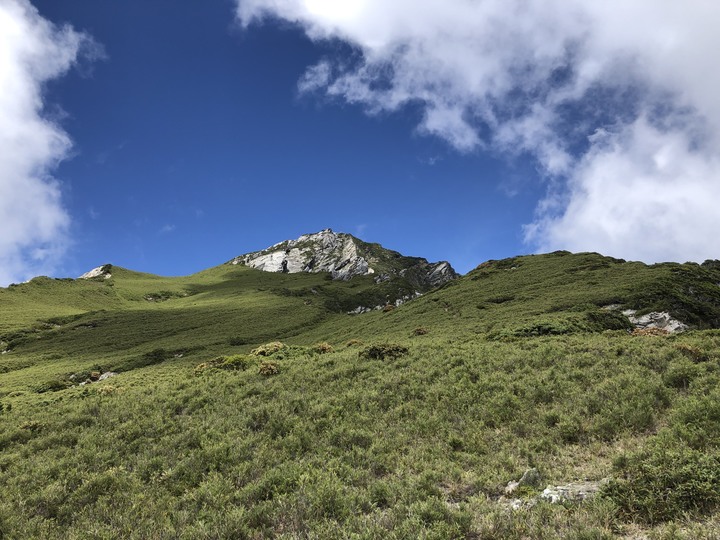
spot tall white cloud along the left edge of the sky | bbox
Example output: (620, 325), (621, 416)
(0, 0), (88, 285)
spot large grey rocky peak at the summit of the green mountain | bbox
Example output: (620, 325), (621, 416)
(230, 229), (458, 291)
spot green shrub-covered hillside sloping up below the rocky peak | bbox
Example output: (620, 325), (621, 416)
(0, 252), (720, 539)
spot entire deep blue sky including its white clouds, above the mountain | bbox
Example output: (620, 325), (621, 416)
(0, 0), (720, 285)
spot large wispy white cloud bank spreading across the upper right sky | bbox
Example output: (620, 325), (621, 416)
(237, 0), (720, 262)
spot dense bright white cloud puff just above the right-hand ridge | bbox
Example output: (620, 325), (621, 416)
(526, 117), (720, 261)
